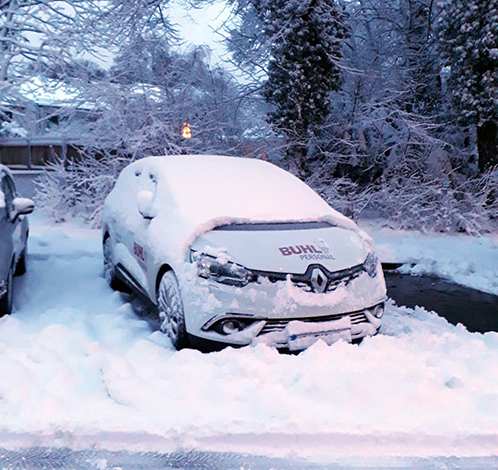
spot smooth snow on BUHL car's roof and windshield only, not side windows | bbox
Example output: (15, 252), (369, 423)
(142, 155), (356, 220)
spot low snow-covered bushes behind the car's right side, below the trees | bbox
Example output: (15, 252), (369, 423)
(309, 168), (498, 235)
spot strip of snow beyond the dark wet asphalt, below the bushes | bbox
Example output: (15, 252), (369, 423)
(361, 223), (498, 295)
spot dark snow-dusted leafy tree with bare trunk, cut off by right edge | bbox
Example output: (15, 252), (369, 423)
(438, 0), (498, 172)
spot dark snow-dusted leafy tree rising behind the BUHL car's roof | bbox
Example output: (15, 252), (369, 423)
(254, 0), (348, 177)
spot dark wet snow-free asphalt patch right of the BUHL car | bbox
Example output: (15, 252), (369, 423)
(384, 271), (498, 333)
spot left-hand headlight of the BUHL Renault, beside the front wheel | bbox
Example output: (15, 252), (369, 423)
(192, 252), (253, 287)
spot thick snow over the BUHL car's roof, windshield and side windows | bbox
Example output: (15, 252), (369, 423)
(111, 155), (366, 260)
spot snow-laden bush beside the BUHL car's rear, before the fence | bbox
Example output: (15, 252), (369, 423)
(35, 150), (130, 228)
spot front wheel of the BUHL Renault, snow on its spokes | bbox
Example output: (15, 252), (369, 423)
(157, 271), (188, 350)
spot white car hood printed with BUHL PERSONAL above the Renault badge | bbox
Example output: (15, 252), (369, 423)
(192, 224), (370, 274)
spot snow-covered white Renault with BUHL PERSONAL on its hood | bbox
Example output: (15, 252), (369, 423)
(103, 155), (386, 351)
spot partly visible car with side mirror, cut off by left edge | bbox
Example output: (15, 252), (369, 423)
(0, 165), (35, 316)
